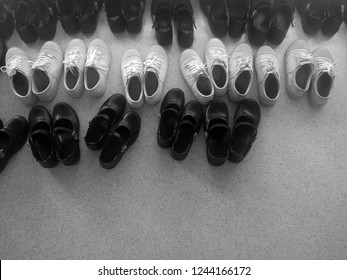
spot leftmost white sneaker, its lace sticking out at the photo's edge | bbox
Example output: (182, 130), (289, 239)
(1, 48), (37, 106)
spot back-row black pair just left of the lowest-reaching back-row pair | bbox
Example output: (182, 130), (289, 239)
(105, 0), (146, 34)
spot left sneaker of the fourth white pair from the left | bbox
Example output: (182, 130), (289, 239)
(180, 49), (214, 105)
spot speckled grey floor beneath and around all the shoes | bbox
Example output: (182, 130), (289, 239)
(0, 1), (347, 259)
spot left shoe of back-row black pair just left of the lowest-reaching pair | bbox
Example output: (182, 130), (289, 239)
(105, 0), (125, 33)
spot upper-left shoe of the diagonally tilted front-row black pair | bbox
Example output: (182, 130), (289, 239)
(84, 93), (126, 150)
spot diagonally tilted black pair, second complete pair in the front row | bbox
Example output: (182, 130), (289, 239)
(84, 94), (141, 169)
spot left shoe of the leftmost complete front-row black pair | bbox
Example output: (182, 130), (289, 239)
(28, 105), (59, 168)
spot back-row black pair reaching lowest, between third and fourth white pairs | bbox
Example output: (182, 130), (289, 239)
(151, 0), (195, 48)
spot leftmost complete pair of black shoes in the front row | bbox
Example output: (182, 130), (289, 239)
(28, 102), (81, 168)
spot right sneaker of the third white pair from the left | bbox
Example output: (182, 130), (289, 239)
(143, 45), (168, 106)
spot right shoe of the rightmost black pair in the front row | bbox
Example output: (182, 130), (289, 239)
(229, 98), (261, 163)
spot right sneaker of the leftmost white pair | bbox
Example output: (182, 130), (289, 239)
(31, 41), (63, 102)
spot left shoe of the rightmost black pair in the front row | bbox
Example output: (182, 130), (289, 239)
(205, 99), (231, 166)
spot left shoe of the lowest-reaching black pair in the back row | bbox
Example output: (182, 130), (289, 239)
(151, 0), (172, 46)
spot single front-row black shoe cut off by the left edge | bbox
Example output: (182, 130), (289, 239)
(0, 116), (29, 172)
